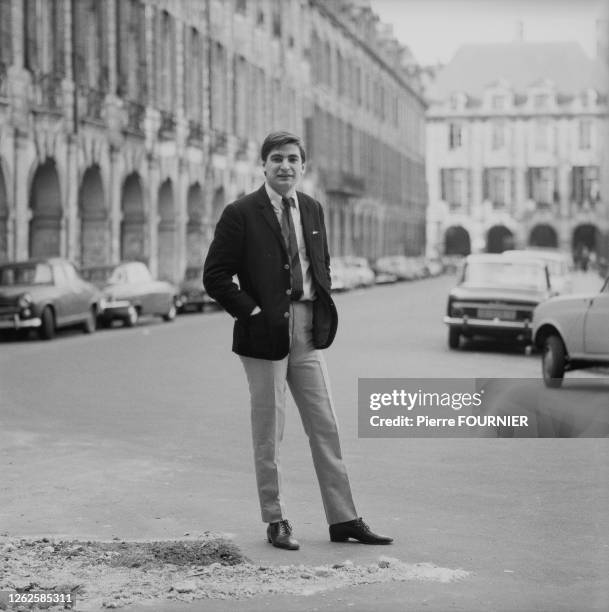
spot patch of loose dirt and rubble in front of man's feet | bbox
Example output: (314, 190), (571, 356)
(0, 532), (468, 610)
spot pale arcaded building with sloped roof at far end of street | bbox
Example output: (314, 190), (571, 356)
(427, 41), (609, 257)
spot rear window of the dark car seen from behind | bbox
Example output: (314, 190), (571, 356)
(463, 261), (546, 290)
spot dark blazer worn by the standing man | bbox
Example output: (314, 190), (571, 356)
(203, 185), (338, 360)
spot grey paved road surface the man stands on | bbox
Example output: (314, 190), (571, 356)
(0, 277), (609, 612)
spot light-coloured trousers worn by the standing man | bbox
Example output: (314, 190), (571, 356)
(241, 302), (357, 524)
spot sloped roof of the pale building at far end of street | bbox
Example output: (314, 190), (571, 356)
(428, 42), (609, 100)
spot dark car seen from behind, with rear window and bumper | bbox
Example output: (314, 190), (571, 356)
(444, 254), (552, 349)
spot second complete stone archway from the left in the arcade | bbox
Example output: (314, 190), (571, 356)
(78, 165), (110, 266)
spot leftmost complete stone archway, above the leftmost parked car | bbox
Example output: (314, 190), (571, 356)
(29, 159), (63, 258)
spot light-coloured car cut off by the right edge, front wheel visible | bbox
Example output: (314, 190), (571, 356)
(533, 277), (609, 387)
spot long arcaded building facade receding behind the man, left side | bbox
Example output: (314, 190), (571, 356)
(0, 0), (426, 281)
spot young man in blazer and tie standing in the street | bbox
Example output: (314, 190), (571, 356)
(203, 132), (392, 550)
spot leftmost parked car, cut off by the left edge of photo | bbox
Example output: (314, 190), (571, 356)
(0, 257), (101, 340)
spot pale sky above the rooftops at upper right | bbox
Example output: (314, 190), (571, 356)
(370, 0), (609, 65)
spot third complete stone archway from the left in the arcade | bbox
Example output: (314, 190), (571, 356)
(120, 172), (148, 263)
